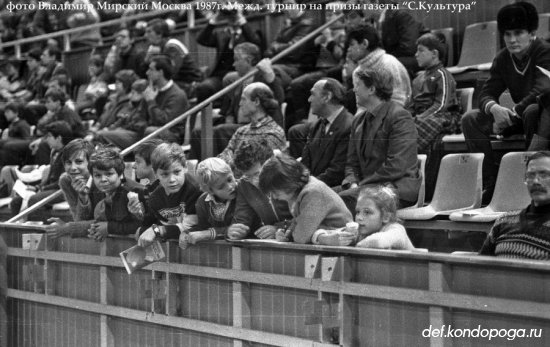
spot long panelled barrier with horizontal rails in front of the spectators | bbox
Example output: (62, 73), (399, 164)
(0, 224), (550, 347)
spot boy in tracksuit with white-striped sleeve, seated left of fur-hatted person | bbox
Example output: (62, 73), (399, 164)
(406, 33), (460, 153)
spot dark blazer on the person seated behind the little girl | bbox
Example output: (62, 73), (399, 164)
(343, 101), (421, 201)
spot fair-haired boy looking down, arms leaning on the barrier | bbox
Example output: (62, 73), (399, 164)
(179, 158), (237, 249)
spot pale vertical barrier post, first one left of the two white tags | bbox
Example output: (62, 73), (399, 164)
(231, 246), (251, 347)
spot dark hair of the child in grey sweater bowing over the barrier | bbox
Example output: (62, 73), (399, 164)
(260, 153), (309, 195)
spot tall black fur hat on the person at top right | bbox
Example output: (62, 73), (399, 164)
(497, 2), (539, 33)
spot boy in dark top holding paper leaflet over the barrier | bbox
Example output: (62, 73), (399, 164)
(138, 143), (201, 247)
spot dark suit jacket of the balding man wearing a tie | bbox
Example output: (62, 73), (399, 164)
(302, 108), (353, 187)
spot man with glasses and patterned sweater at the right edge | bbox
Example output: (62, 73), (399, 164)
(479, 152), (550, 260)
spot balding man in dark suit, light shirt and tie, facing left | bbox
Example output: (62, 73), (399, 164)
(302, 78), (353, 187)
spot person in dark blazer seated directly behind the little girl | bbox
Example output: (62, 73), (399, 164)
(340, 69), (421, 213)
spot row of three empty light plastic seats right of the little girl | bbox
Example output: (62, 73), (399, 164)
(397, 152), (533, 222)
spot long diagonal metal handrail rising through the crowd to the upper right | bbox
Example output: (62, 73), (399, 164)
(8, 14), (344, 223)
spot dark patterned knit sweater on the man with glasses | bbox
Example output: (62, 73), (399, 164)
(479, 205), (550, 260)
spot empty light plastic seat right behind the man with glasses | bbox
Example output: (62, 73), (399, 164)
(449, 152), (533, 222)
